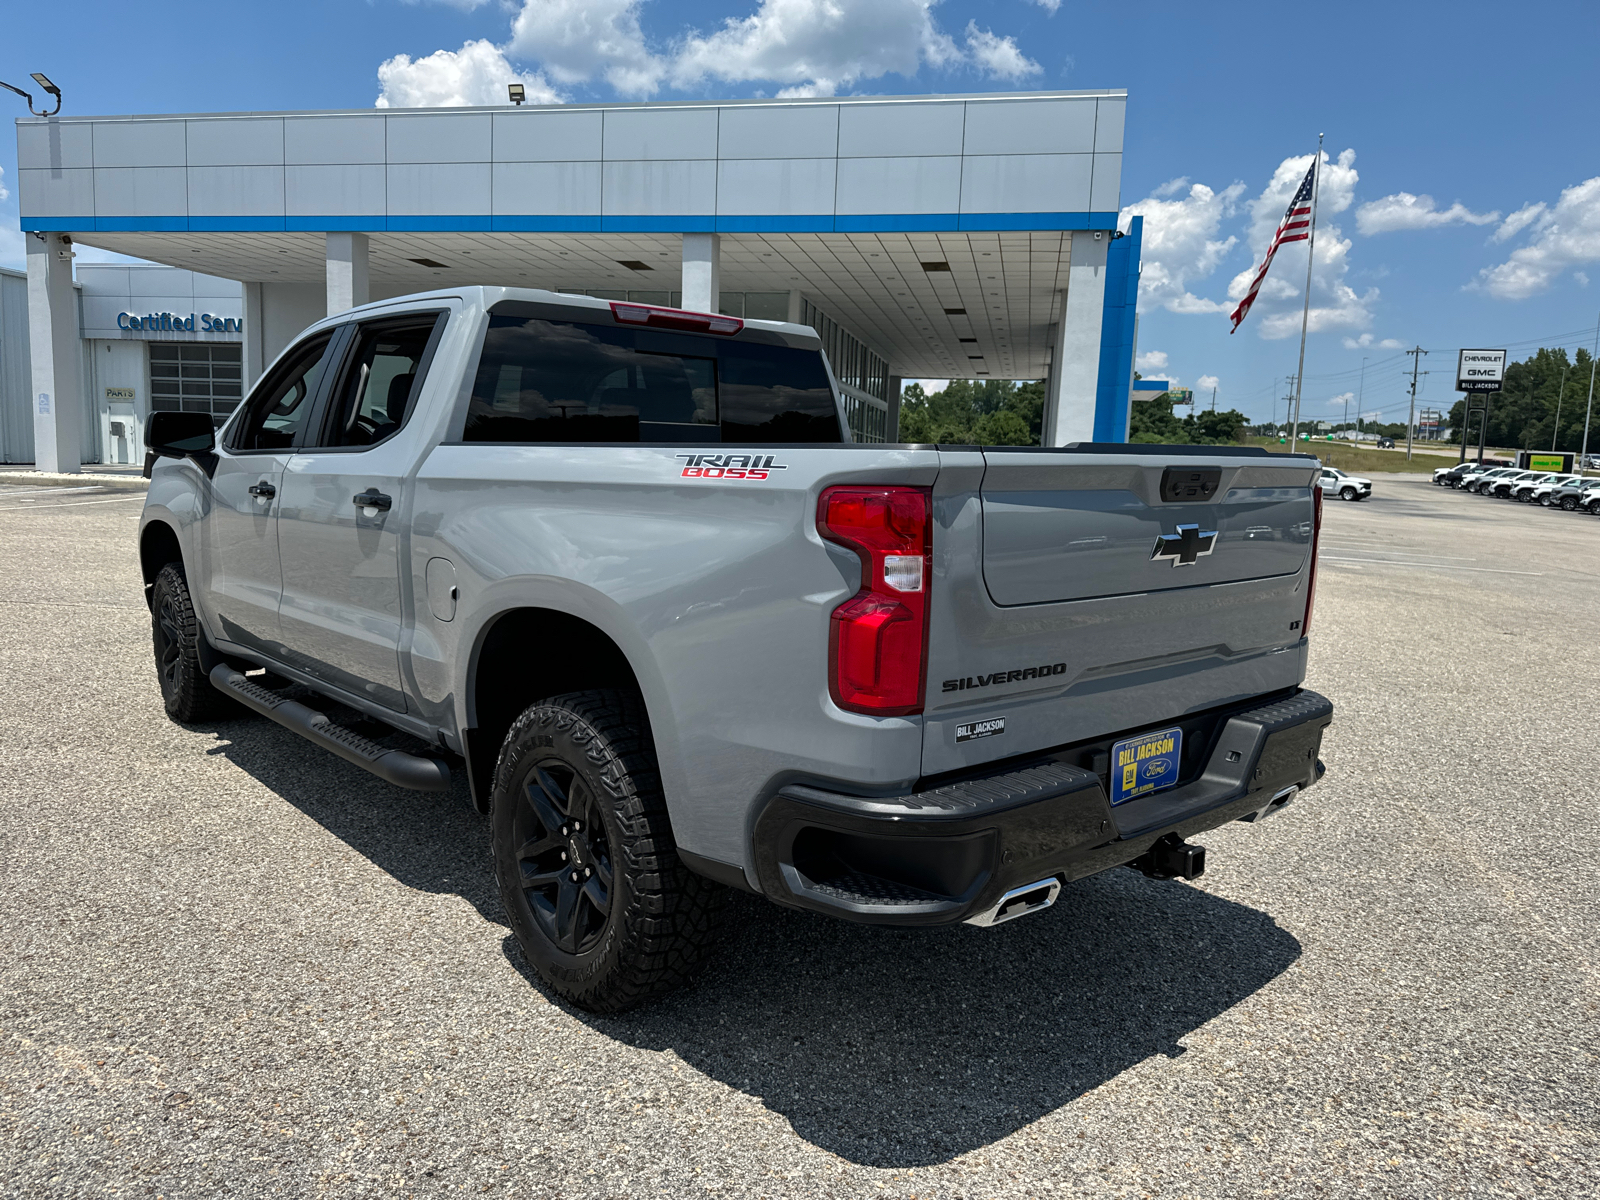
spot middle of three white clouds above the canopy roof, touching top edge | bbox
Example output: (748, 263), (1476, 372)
(506, 0), (667, 96)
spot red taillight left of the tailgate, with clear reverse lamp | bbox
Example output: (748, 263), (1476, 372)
(816, 486), (933, 717)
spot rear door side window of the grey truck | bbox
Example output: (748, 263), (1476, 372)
(320, 312), (443, 446)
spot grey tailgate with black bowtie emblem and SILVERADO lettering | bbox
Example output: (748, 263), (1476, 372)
(923, 446), (1315, 774)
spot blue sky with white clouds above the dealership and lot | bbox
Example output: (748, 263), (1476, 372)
(0, 0), (1600, 419)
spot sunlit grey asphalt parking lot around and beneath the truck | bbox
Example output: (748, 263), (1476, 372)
(0, 478), (1600, 1200)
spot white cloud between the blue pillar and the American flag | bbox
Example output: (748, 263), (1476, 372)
(1120, 179), (1245, 314)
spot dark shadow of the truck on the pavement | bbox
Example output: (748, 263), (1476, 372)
(203, 722), (1301, 1166)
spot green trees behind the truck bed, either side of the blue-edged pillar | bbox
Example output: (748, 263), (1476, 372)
(899, 379), (1245, 446)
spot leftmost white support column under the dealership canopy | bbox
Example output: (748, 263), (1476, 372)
(22, 234), (83, 475)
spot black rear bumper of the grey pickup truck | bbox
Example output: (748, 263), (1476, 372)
(754, 691), (1333, 925)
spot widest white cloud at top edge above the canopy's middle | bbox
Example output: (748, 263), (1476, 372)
(665, 0), (953, 96)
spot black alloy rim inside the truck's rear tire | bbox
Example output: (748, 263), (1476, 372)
(512, 758), (613, 954)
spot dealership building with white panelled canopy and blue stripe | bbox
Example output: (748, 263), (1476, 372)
(0, 91), (1141, 470)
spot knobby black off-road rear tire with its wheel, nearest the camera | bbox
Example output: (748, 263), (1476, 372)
(490, 690), (726, 1013)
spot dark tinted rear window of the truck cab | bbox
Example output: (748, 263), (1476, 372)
(462, 315), (842, 445)
